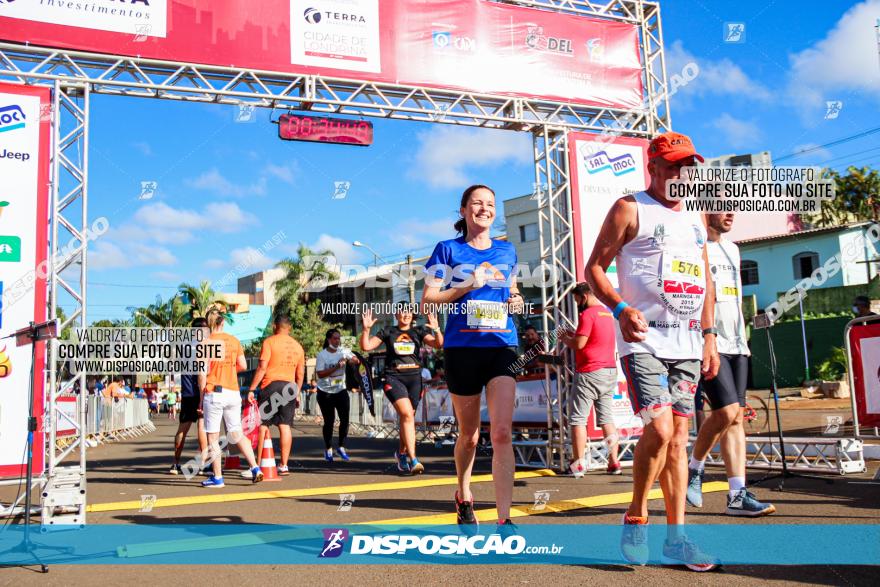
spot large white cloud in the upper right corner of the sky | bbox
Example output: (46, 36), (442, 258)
(788, 0), (880, 115)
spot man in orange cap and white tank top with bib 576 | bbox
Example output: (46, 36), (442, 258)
(585, 132), (719, 571)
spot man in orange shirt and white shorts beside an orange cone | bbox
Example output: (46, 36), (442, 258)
(199, 306), (263, 487)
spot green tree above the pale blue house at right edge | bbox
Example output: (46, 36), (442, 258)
(804, 166), (880, 228)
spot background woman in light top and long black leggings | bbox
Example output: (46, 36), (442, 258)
(315, 328), (360, 463)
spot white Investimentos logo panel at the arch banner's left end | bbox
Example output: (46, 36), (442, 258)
(0, 0), (170, 38)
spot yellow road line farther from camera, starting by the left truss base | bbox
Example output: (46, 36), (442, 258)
(86, 469), (556, 512)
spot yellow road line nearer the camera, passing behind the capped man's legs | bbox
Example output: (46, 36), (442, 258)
(363, 481), (727, 526)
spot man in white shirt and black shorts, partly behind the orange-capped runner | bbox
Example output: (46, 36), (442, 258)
(687, 214), (776, 517)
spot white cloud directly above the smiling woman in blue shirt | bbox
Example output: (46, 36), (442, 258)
(409, 126), (532, 188)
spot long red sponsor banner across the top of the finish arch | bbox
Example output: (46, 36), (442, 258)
(0, 0), (642, 108)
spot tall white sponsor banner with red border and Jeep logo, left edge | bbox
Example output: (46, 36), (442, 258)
(0, 81), (50, 477)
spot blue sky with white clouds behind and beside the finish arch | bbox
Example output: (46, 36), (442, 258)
(79, 0), (880, 321)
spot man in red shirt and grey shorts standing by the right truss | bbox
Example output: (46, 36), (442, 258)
(561, 283), (620, 477)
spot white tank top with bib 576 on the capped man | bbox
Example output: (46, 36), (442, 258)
(617, 192), (706, 360)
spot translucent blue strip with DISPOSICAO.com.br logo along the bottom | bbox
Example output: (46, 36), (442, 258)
(0, 524), (880, 565)
